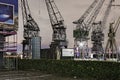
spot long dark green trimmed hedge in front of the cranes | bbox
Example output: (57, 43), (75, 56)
(19, 60), (120, 80)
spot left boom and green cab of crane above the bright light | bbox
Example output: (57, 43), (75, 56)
(73, 0), (98, 39)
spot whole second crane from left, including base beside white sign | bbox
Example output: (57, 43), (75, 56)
(45, 0), (67, 59)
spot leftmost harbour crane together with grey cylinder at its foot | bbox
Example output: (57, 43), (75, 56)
(21, 0), (41, 59)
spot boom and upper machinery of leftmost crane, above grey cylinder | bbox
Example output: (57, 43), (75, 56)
(21, 0), (40, 38)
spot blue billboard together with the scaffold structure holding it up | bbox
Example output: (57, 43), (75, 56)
(0, 0), (18, 69)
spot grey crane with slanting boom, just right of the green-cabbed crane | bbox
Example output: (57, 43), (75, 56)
(91, 0), (114, 56)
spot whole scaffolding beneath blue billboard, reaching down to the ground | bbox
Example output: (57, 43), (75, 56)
(0, 27), (17, 68)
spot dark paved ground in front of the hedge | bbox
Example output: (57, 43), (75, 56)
(0, 71), (80, 80)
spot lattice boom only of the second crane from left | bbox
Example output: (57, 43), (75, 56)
(46, 0), (64, 29)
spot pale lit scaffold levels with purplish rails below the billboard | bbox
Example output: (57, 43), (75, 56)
(0, 30), (17, 52)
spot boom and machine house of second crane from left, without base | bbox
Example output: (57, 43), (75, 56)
(45, 0), (66, 45)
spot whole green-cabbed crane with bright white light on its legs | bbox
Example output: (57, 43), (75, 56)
(73, 0), (105, 58)
